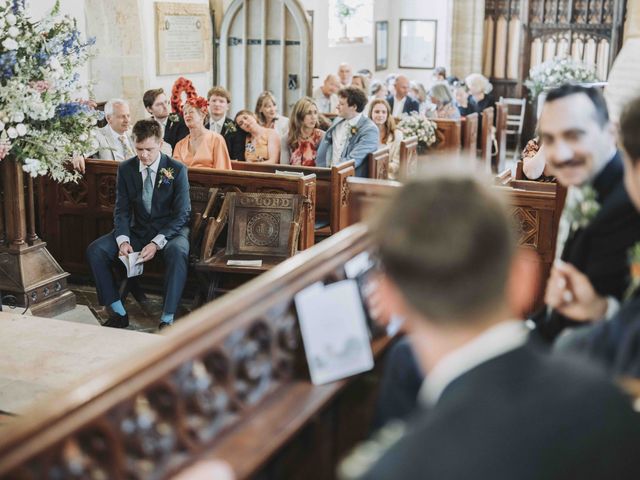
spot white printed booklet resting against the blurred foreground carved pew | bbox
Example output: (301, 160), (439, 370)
(295, 280), (373, 385)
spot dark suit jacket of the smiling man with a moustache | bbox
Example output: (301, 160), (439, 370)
(533, 152), (640, 340)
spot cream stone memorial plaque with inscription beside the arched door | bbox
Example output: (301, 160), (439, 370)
(155, 3), (212, 75)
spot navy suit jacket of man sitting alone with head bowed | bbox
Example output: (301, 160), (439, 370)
(113, 154), (191, 242)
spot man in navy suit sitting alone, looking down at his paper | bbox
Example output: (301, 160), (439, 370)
(87, 120), (191, 329)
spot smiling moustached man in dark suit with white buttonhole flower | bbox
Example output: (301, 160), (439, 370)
(533, 84), (640, 341)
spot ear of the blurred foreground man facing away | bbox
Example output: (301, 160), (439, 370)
(507, 247), (540, 318)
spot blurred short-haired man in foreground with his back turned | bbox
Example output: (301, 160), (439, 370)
(338, 171), (640, 480)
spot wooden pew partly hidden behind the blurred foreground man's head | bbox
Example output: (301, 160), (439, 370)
(347, 177), (564, 312)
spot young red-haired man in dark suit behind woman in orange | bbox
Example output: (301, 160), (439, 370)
(205, 86), (246, 161)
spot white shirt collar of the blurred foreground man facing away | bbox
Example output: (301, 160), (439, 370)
(418, 320), (529, 406)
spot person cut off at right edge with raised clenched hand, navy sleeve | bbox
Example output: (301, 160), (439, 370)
(548, 98), (640, 378)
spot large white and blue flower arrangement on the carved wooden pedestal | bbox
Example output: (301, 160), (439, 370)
(0, 0), (98, 182)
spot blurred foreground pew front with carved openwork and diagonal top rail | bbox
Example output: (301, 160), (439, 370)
(0, 225), (391, 480)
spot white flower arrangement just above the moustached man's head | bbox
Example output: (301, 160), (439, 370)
(524, 57), (598, 100)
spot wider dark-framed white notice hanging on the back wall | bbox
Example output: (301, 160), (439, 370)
(398, 19), (438, 69)
